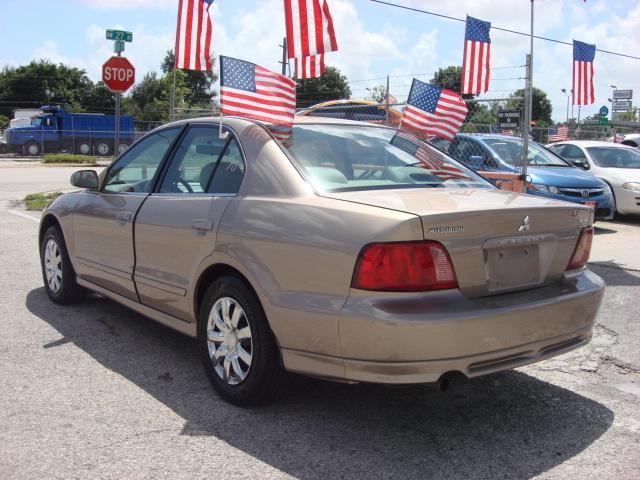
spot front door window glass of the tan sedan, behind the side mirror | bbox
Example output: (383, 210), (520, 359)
(102, 128), (180, 193)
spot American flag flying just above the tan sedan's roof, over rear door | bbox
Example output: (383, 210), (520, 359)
(220, 56), (296, 126)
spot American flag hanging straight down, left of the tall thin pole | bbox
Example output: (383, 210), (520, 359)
(462, 16), (491, 93)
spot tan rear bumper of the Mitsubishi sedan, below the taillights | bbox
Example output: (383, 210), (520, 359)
(283, 270), (604, 384)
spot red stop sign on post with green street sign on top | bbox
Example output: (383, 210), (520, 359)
(102, 29), (136, 156)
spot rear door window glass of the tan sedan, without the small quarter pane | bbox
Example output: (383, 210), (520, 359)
(160, 126), (227, 193)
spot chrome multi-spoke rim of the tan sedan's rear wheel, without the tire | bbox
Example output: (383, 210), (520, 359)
(207, 297), (253, 385)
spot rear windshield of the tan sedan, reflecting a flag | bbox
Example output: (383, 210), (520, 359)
(281, 124), (493, 192)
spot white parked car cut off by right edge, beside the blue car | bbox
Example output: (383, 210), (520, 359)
(547, 140), (640, 214)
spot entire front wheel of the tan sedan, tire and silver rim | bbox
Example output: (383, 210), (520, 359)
(40, 226), (85, 305)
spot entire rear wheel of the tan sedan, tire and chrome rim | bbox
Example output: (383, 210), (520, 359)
(198, 276), (284, 405)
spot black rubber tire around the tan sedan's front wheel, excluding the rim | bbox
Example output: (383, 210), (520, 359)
(40, 226), (86, 305)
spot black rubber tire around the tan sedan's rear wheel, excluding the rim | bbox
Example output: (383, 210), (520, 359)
(198, 276), (285, 406)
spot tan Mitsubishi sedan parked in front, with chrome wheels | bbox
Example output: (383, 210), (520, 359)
(40, 117), (604, 404)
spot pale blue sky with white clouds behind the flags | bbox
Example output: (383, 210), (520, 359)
(0, 0), (640, 121)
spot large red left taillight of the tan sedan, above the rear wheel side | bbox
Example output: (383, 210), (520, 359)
(351, 241), (458, 292)
